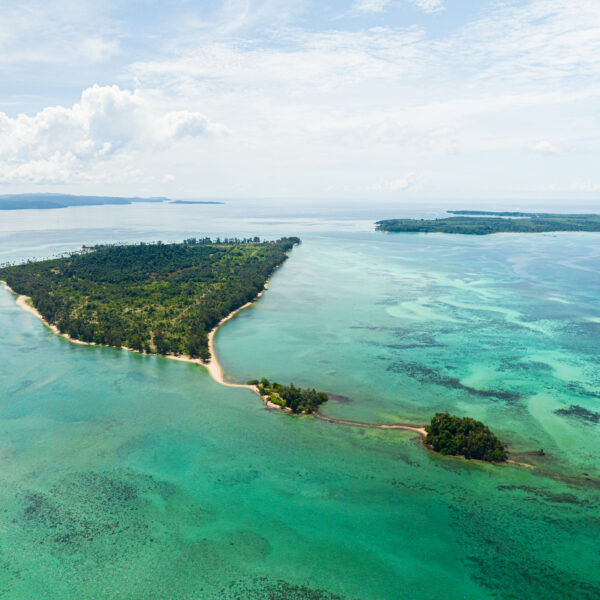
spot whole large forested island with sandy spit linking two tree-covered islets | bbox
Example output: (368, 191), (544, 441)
(0, 237), (507, 462)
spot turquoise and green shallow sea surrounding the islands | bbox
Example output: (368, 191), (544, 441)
(0, 201), (600, 600)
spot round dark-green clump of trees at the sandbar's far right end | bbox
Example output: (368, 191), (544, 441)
(425, 412), (508, 461)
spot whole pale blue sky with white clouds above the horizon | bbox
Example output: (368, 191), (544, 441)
(0, 0), (600, 201)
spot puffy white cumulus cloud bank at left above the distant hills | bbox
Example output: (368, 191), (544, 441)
(0, 85), (226, 182)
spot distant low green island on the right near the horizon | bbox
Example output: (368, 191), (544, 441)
(375, 210), (600, 235)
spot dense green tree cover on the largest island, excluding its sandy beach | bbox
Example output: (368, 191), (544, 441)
(0, 237), (300, 359)
